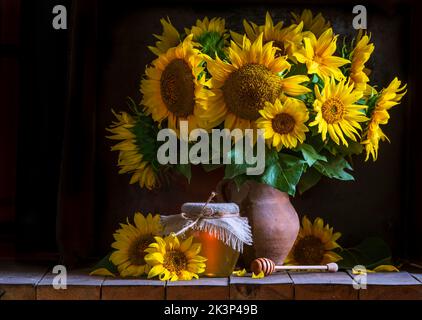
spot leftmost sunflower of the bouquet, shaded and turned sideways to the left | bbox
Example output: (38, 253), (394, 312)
(107, 111), (158, 190)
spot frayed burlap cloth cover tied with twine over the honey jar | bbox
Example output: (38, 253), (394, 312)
(161, 202), (252, 252)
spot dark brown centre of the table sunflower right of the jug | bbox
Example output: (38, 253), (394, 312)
(293, 236), (325, 265)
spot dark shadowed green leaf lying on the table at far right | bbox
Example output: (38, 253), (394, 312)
(338, 237), (392, 269)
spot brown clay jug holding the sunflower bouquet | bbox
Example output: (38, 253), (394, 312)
(217, 180), (300, 267)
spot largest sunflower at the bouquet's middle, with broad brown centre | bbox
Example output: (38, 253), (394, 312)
(199, 33), (310, 130)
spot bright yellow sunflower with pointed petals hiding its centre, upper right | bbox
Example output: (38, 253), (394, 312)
(293, 28), (350, 80)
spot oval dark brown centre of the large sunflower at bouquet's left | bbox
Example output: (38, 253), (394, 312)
(160, 59), (195, 117)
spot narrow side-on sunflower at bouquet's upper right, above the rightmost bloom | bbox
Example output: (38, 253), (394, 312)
(350, 33), (375, 92)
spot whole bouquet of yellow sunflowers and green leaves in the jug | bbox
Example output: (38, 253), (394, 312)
(108, 10), (406, 195)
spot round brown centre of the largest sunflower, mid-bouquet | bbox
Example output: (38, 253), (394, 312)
(222, 64), (282, 120)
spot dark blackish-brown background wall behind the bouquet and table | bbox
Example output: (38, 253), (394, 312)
(0, 0), (422, 262)
